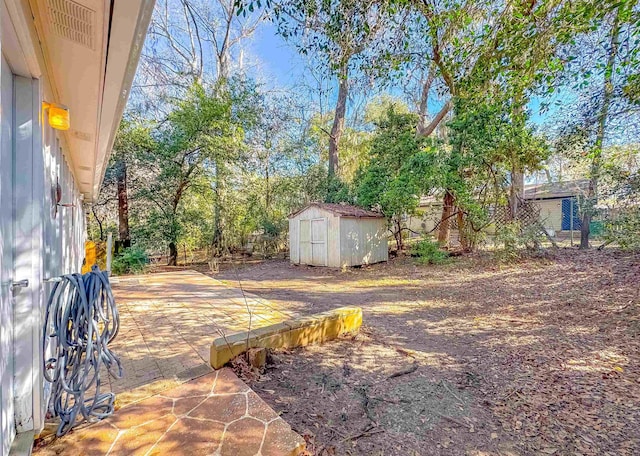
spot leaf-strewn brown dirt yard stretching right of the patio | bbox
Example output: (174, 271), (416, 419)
(215, 249), (640, 455)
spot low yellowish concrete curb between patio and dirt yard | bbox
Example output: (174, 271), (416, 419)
(210, 307), (362, 369)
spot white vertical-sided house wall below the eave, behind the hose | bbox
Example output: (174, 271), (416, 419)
(0, 64), (85, 456)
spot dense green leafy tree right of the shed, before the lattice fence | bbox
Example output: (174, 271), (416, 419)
(441, 99), (550, 246)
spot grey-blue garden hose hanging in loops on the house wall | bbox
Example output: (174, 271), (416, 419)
(42, 266), (122, 437)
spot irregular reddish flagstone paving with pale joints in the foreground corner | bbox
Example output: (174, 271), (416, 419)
(36, 368), (304, 456)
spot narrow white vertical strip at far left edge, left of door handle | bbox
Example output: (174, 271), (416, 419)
(0, 57), (15, 456)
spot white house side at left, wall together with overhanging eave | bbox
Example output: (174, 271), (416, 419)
(0, 0), (154, 448)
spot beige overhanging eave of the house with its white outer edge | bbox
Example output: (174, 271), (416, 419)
(16, 0), (155, 202)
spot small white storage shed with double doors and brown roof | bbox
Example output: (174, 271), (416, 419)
(289, 203), (389, 268)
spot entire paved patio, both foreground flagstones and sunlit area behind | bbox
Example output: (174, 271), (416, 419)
(35, 271), (303, 456)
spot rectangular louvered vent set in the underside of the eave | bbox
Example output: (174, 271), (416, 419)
(47, 0), (95, 49)
